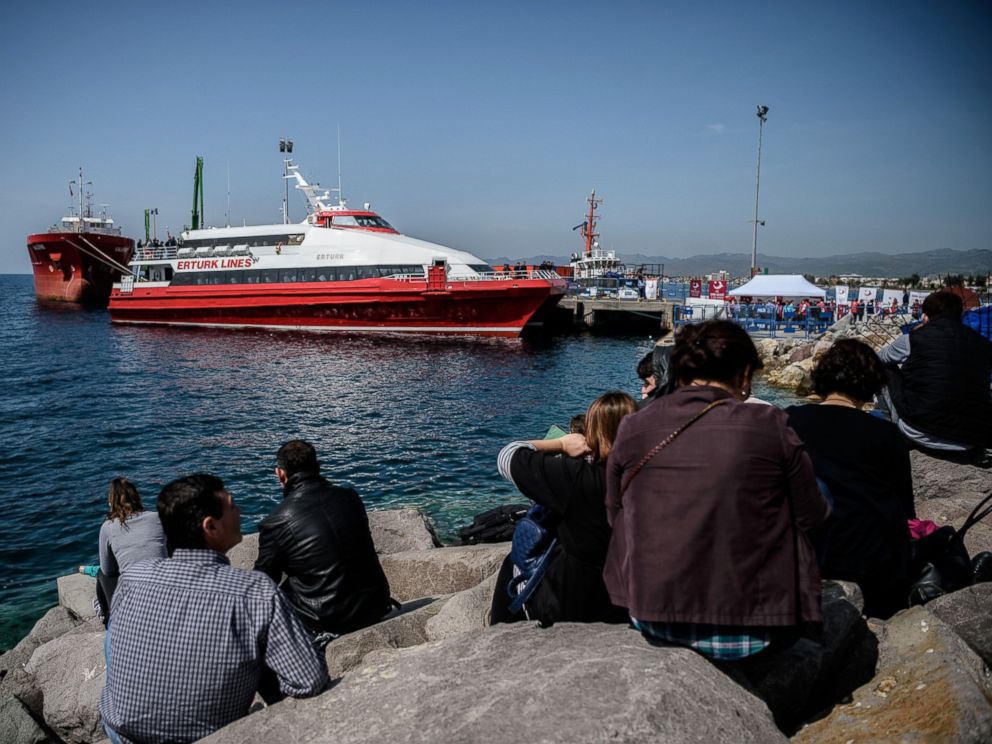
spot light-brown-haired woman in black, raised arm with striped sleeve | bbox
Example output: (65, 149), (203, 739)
(492, 391), (637, 626)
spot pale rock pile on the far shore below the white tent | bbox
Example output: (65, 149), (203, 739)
(755, 316), (904, 395)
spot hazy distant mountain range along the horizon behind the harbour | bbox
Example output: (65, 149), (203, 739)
(487, 249), (992, 278)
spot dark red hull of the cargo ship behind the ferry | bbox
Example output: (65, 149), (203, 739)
(28, 232), (134, 306)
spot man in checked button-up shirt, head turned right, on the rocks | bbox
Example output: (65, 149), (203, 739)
(100, 474), (328, 744)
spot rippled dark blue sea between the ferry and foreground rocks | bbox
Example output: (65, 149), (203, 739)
(0, 275), (804, 649)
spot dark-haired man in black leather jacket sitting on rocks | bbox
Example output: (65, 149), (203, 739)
(255, 439), (392, 636)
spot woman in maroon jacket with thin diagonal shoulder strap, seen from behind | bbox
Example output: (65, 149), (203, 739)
(604, 321), (830, 659)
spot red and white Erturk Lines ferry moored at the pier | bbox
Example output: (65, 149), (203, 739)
(110, 162), (565, 336)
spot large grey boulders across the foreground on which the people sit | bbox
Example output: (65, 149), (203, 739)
(0, 456), (992, 744)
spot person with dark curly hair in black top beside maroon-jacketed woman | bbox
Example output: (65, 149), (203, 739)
(787, 339), (916, 618)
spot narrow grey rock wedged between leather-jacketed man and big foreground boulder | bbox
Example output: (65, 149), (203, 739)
(325, 597), (446, 679)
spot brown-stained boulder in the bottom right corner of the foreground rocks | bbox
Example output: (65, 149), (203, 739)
(794, 607), (992, 744)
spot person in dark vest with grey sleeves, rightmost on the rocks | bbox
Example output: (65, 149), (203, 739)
(879, 290), (992, 453)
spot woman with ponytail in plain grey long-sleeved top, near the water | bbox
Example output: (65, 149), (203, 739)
(96, 478), (166, 626)
